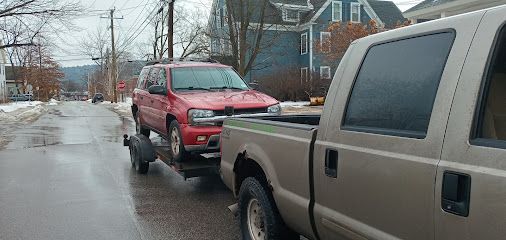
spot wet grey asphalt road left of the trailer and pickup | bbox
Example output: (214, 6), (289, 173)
(0, 102), (239, 240)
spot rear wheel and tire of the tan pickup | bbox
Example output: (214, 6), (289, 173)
(239, 177), (299, 240)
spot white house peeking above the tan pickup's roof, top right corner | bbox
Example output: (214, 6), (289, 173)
(402, 0), (506, 23)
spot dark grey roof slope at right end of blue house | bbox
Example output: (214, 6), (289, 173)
(367, 0), (406, 28)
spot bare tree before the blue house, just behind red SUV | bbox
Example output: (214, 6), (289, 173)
(208, 0), (286, 76)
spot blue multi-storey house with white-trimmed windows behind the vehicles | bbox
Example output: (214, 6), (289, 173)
(208, 0), (405, 81)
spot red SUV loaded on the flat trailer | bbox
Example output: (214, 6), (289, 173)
(132, 60), (281, 162)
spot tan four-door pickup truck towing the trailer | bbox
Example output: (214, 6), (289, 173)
(221, 6), (506, 240)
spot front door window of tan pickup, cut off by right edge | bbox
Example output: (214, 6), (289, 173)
(474, 24), (506, 146)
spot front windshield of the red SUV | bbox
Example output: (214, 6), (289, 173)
(172, 67), (249, 90)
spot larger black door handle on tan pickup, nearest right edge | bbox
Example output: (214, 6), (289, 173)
(441, 171), (471, 217)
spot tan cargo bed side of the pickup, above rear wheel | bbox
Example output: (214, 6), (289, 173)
(221, 115), (320, 236)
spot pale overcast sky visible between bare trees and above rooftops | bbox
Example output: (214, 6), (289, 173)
(54, 0), (421, 67)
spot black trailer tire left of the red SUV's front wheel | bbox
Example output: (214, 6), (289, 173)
(130, 134), (156, 174)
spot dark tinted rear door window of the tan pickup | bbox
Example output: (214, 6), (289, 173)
(343, 32), (455, 138)
